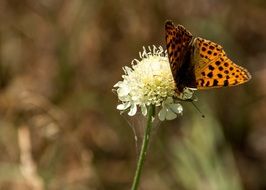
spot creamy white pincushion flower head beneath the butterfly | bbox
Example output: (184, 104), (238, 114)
(114, 46), (193, 121)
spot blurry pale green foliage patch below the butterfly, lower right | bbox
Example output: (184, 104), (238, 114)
(172, 113), (242, 190)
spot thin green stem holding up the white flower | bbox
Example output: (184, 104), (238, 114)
(131, 105), (155, 190)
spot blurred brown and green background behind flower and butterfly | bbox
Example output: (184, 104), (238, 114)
(0, 0), (266, 190)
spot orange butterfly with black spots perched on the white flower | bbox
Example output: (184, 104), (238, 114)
(165, 21), (251, 94)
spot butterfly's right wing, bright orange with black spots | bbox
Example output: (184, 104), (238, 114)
(191, 38), (251, 89)
